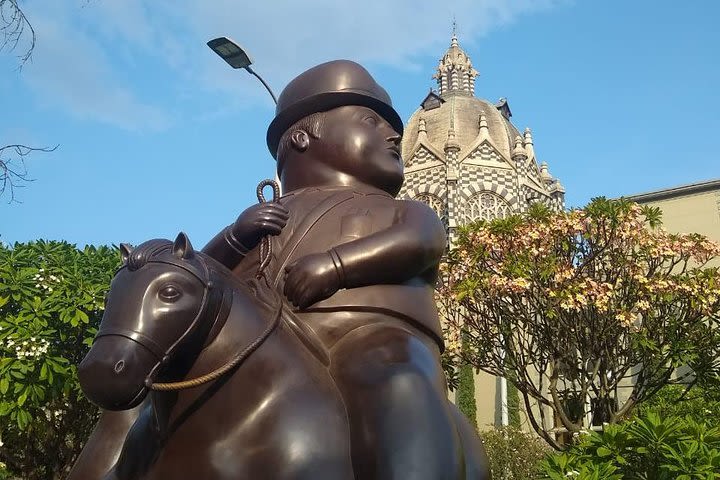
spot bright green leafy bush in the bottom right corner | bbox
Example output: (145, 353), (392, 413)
(542, 412), (720, 480)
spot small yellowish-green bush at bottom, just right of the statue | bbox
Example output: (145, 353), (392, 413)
(480, 426), (550, 480)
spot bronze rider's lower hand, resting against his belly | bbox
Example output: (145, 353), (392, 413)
(283, 253), (341, 310)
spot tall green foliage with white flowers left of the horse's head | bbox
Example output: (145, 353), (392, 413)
(0, 241), (120, 480)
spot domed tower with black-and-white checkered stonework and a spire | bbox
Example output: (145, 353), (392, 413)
(400, 34), (565, 241)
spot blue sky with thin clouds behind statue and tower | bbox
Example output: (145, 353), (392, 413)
(0, 0), (720, 248)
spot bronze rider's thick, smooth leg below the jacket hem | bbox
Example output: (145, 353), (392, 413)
(331, 322), (465, 480)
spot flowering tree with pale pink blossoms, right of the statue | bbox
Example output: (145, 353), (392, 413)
(440, 198), (720, 449)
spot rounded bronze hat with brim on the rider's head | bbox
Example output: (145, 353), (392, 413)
(267, 60), (403, 158)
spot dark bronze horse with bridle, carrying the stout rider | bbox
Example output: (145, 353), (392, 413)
(69, 233), (486, 480)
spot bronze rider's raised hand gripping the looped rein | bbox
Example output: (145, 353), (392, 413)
(232, 202), (290, 250)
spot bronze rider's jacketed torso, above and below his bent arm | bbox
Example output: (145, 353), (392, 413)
(235, 188), (442, 348)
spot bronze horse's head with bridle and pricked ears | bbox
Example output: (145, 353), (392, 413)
(78, 233), (225, 410)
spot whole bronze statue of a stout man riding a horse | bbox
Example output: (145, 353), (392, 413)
(71, 60), (489, 480)
